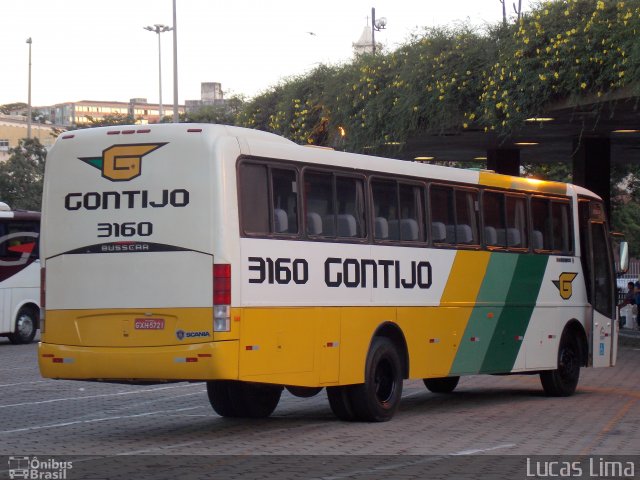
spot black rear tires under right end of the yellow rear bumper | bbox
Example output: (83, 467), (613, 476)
(207, 380), (282, 418)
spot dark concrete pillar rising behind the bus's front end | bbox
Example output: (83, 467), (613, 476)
(572, 137), (611, 215)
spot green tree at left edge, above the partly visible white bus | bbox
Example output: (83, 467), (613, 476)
(0, 138), (47, 210)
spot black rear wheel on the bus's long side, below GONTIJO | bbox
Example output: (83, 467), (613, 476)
(347, 337), (402, 422)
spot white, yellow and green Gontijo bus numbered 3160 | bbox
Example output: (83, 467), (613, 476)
(39, 124), (617, 421)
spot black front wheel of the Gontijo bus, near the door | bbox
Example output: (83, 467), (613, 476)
(540, 331), (582, 397)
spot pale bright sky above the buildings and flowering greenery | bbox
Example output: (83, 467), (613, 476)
(0, 0), (534, 106)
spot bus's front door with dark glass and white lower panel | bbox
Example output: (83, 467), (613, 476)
(579, 198), (617, 367)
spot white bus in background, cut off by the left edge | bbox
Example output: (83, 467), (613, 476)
(0, 202), (40, 344)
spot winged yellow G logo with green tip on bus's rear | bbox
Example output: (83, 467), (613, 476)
(78, 142), (167, 182)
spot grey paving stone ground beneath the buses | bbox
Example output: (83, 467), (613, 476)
(0, 339), (640, 480)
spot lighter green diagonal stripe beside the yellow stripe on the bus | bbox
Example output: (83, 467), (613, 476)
(450, 253), (520, 375)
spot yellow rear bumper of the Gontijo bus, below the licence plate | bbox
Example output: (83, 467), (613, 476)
(38, 340), (238, 381)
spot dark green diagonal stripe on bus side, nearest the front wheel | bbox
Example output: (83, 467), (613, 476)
(480, 255), (549, 373)
